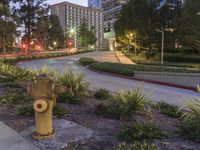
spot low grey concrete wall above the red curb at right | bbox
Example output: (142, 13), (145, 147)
(134, 71), (200, 88)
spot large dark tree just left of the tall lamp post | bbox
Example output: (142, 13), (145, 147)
(115, 0), (157, 54)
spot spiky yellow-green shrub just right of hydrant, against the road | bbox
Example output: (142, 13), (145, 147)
(60, 70), (89, 96)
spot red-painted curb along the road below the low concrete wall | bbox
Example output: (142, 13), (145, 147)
(88, 67), (196, 92)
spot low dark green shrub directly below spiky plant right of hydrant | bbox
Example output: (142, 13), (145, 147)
(57, 93), (83, 105)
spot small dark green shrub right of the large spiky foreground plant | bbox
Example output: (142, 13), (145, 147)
(158, 101), (183, 118)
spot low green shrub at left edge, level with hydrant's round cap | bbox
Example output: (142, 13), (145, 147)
(0, 94), (32, 104)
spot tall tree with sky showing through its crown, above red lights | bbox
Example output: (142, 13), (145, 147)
(13, 0), (48, 49)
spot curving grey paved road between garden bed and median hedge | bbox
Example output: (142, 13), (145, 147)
(19, 52), (200, 107)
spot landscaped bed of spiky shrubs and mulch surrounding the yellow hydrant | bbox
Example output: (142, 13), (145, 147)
(0, 63), (200, 150)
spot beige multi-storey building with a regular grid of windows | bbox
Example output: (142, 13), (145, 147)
(51, 2), (103, 49)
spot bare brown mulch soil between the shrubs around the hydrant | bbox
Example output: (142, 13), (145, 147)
(0, 82), (200, 150)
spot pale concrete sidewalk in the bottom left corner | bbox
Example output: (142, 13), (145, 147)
(0, 121), (39, 150)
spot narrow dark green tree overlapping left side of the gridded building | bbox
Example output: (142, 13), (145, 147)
(48, 15), (65, 47)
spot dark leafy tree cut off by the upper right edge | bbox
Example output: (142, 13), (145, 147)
(174, 0), (200, 54)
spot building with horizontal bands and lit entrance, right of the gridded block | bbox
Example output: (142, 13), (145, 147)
(102, 0), (128, 51)
